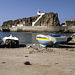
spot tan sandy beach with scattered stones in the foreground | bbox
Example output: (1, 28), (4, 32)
(0, 43), (75, 75)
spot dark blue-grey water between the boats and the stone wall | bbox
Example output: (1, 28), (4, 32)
(0, 32), (73, 44)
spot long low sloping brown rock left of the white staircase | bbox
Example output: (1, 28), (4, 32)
(2, 16), (38, 27)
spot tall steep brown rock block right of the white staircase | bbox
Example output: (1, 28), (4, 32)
(35, 12), (60, 27)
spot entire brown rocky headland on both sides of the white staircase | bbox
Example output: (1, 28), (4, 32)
(2, 12), (60, 27)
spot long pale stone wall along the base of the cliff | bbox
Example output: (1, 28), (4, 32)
(0, 26), (75, 33)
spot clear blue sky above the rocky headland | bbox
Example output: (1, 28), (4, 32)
(0, 0), (75, 26)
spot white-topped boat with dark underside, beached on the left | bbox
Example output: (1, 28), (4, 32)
(3, 35), (19, 48)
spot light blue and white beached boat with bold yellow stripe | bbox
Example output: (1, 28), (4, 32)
(36, 35), (60, 47)
